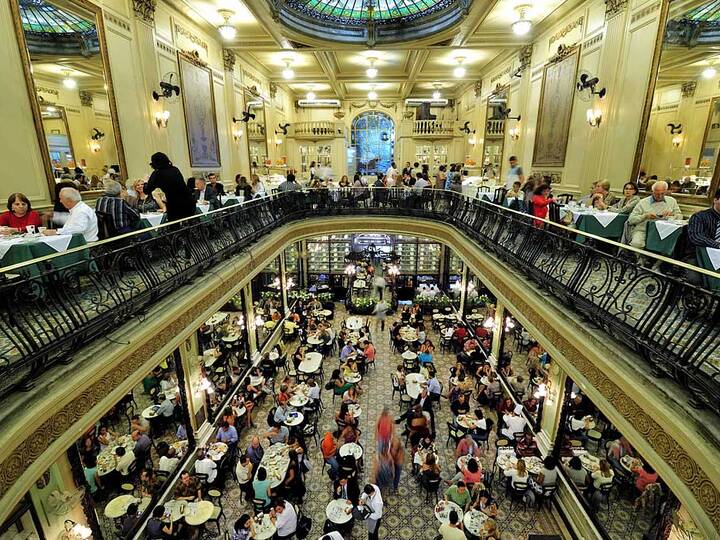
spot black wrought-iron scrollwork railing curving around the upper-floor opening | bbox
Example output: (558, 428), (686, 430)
(0, 188), (720, 413)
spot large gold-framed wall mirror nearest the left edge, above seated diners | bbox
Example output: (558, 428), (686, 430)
(10, 0), (126, 196)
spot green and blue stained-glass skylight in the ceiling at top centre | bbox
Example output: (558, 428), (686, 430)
(286, 0), (452, 24)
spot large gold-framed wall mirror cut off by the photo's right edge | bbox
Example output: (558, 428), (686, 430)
(635, 0), (720, 203)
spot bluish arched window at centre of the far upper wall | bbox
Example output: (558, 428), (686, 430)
(350, 111), (395, 174)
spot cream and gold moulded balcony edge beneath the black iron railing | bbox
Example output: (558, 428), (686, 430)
(0, 216), (720, 531)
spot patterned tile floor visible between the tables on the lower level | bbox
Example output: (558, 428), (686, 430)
(217, 304), (562, 540)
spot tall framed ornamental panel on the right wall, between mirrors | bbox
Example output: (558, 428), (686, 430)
(533, 45), (580, 167)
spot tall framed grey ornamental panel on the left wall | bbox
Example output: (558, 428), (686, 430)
(178, 53), (220, 167)
